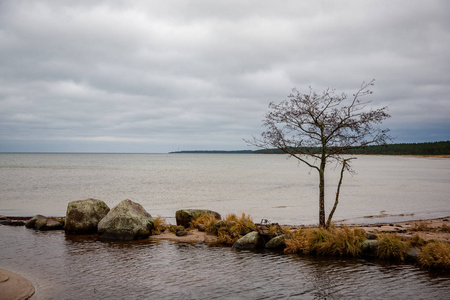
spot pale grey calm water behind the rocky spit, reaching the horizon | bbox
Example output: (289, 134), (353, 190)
(0, 154), (450, 225)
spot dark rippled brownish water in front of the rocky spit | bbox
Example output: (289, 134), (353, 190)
(0, 226), (450, 299)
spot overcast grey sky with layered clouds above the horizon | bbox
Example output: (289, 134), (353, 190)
(0, 0), (450, 153)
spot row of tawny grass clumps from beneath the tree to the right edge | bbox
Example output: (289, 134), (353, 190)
(284, 226), (450, 270)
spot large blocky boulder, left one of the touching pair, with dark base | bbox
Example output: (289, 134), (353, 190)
(64, 198), (109, 234)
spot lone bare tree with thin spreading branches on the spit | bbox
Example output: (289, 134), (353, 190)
(247, 80), (390, 227)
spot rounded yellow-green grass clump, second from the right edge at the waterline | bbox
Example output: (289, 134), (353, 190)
(377, 234), (409, 261)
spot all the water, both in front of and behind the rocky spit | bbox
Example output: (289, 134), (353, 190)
(0, 153), (450, 299)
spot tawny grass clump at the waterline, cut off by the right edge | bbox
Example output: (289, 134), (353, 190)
(419, 241), (450, 270)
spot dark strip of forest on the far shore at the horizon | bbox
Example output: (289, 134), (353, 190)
(171, 141), (450, 155)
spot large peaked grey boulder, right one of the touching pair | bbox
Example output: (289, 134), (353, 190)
(98, 199), (153, 241)
